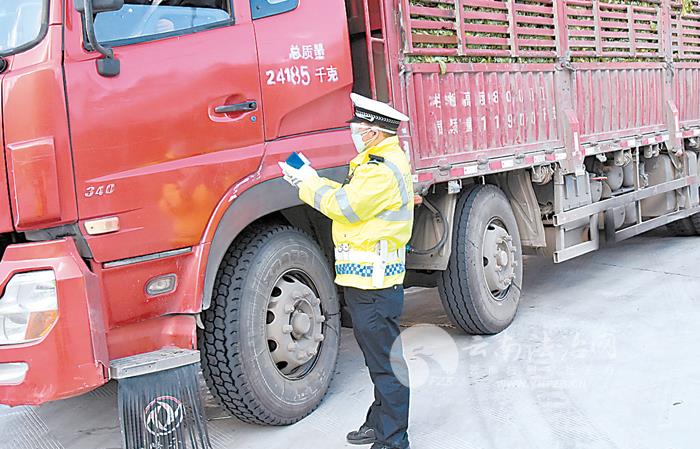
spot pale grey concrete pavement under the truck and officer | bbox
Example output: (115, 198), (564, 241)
(0, 236), (700, 449)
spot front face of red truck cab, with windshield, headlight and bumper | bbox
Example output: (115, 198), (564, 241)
(0, 1), (108, 404)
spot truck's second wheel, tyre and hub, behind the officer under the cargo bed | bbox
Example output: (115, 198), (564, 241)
(438, 185), (523, 335)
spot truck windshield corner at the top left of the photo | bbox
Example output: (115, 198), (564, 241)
(0, 0), (48, 55)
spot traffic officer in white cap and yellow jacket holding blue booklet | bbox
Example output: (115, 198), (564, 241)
(280, 94), (413, 449)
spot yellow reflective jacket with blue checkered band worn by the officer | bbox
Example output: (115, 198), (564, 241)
(299, 137), (413, 290)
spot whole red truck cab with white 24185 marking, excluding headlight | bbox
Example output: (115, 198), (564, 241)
(0, 0), (360, 405)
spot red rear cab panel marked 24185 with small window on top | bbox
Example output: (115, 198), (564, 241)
(250, 0), (352, 142)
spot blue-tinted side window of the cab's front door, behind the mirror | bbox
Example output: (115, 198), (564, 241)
(95, 0), (231, 46)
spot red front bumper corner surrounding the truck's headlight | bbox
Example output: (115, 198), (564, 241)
(0, 239), (108, 406)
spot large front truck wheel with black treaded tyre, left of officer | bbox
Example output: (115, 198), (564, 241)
(199, 225), (340, 425)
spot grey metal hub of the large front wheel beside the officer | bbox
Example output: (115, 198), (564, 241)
(267, 274), (326, 375)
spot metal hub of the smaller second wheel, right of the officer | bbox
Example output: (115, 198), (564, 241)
(482, 220), (517, 299)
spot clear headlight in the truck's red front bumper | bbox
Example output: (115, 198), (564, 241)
(0, 270), (58, 345)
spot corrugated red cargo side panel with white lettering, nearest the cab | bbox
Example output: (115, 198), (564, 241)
(409, 64), (559, 168)
